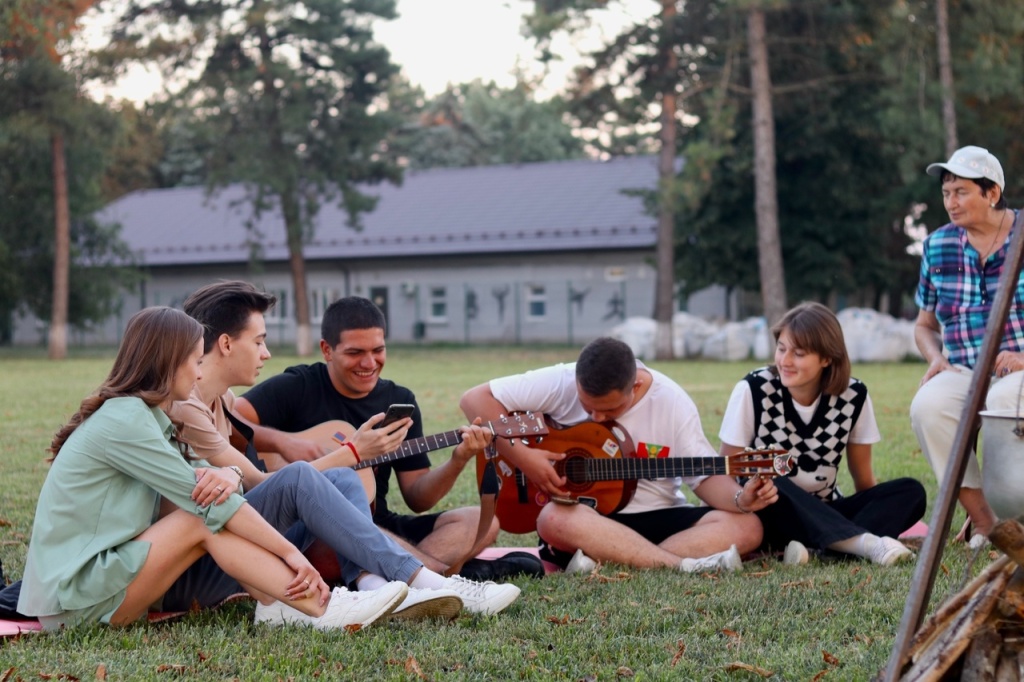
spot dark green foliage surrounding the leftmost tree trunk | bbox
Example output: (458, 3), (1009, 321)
(0, 57), (138, 341)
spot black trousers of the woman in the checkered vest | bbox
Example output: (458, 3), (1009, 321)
(757, 477), (927, 550)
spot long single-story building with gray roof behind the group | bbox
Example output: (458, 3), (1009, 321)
(15, 157), (736, 347)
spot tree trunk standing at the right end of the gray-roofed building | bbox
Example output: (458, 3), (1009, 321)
(654, 0), (679, 359)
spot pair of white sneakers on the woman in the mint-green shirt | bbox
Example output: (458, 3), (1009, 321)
(256, 581), (409, 632)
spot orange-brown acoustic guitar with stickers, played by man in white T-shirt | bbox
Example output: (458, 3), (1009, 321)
(476, 417), (793, 534)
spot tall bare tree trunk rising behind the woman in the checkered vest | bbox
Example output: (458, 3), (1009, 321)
(746, 8), (786, 328)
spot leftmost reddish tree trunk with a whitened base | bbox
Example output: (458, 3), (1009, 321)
(49, 131), (71, 359)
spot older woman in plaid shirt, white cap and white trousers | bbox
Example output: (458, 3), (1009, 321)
(910, 146), (1024, 547)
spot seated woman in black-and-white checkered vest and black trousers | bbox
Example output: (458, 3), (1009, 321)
(719, 303), (926, 566)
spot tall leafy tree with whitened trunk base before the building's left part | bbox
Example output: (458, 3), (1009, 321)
(103, 0), (400, 355)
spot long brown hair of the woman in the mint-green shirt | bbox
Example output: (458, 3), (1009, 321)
(48, 306), (203, 461)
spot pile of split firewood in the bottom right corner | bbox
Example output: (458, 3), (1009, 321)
(900, 520), (1024, 682)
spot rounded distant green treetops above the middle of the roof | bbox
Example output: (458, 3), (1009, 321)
(389, 80), (583, 169)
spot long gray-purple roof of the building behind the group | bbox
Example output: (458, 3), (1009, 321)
(98, 157), (657, 265)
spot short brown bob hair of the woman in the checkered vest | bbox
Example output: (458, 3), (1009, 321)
(771, 302), (850, 395)
